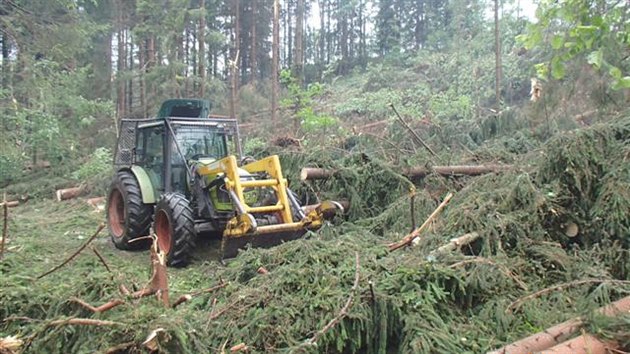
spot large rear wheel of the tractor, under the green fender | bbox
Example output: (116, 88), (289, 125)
(105, 171), (153, 250)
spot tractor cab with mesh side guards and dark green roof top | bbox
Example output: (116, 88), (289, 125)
(114, 99), (241, 196)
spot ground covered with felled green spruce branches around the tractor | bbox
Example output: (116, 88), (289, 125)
(0, 118), (630, 354)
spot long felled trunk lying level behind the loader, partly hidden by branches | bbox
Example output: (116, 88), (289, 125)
(300, 165), (512, 181)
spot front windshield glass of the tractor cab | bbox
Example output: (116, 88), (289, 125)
(173, 125), (228, 160)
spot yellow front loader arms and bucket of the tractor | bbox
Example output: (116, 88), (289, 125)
(198, 155), (343, 258)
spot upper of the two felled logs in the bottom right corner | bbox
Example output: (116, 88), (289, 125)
(488, 296), (630, 354)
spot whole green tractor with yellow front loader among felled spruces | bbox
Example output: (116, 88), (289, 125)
(106, 99), (340, 266)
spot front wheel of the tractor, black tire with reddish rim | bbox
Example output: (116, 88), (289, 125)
(153, 193), (196, 267)
